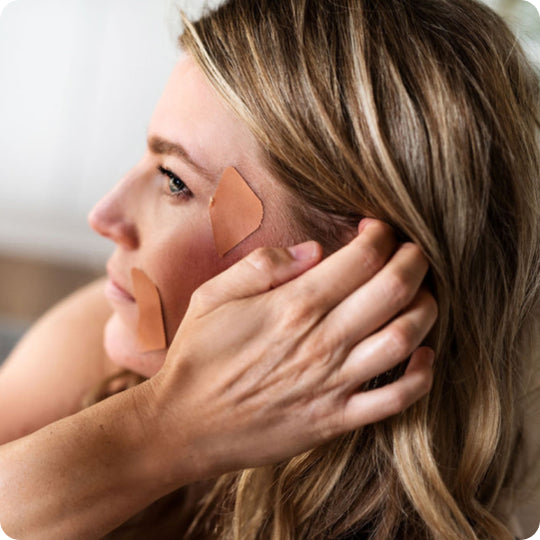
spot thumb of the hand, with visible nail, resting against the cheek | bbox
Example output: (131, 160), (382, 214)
(190, 241), (323, 316)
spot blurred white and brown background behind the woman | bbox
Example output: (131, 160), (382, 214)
(0, 0), (540, 362)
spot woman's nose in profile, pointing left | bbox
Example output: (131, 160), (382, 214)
(88, 182), (139, 249)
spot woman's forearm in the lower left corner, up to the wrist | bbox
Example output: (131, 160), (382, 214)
(0, 385), (193, 540)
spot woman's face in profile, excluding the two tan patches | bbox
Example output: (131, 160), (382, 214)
(89, 55), (302, 377)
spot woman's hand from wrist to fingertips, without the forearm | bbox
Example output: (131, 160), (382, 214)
(149, 219), (437, 479)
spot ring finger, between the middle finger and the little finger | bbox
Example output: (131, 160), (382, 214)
(337, 288), (438, 389)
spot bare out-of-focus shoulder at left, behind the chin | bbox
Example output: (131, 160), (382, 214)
(0, 280), (119, 444)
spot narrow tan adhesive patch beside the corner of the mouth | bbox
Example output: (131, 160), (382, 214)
(131, 268), (167, 352)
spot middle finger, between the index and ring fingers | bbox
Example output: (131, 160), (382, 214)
(322, 243), (429, 348)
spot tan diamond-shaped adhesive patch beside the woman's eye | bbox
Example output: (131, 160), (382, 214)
(209, 167), (263, 257)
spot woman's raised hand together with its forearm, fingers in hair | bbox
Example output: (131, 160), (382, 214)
(0, 220), (437, 539)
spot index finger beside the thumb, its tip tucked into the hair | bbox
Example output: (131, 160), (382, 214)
(284, 219), (397, 313)
